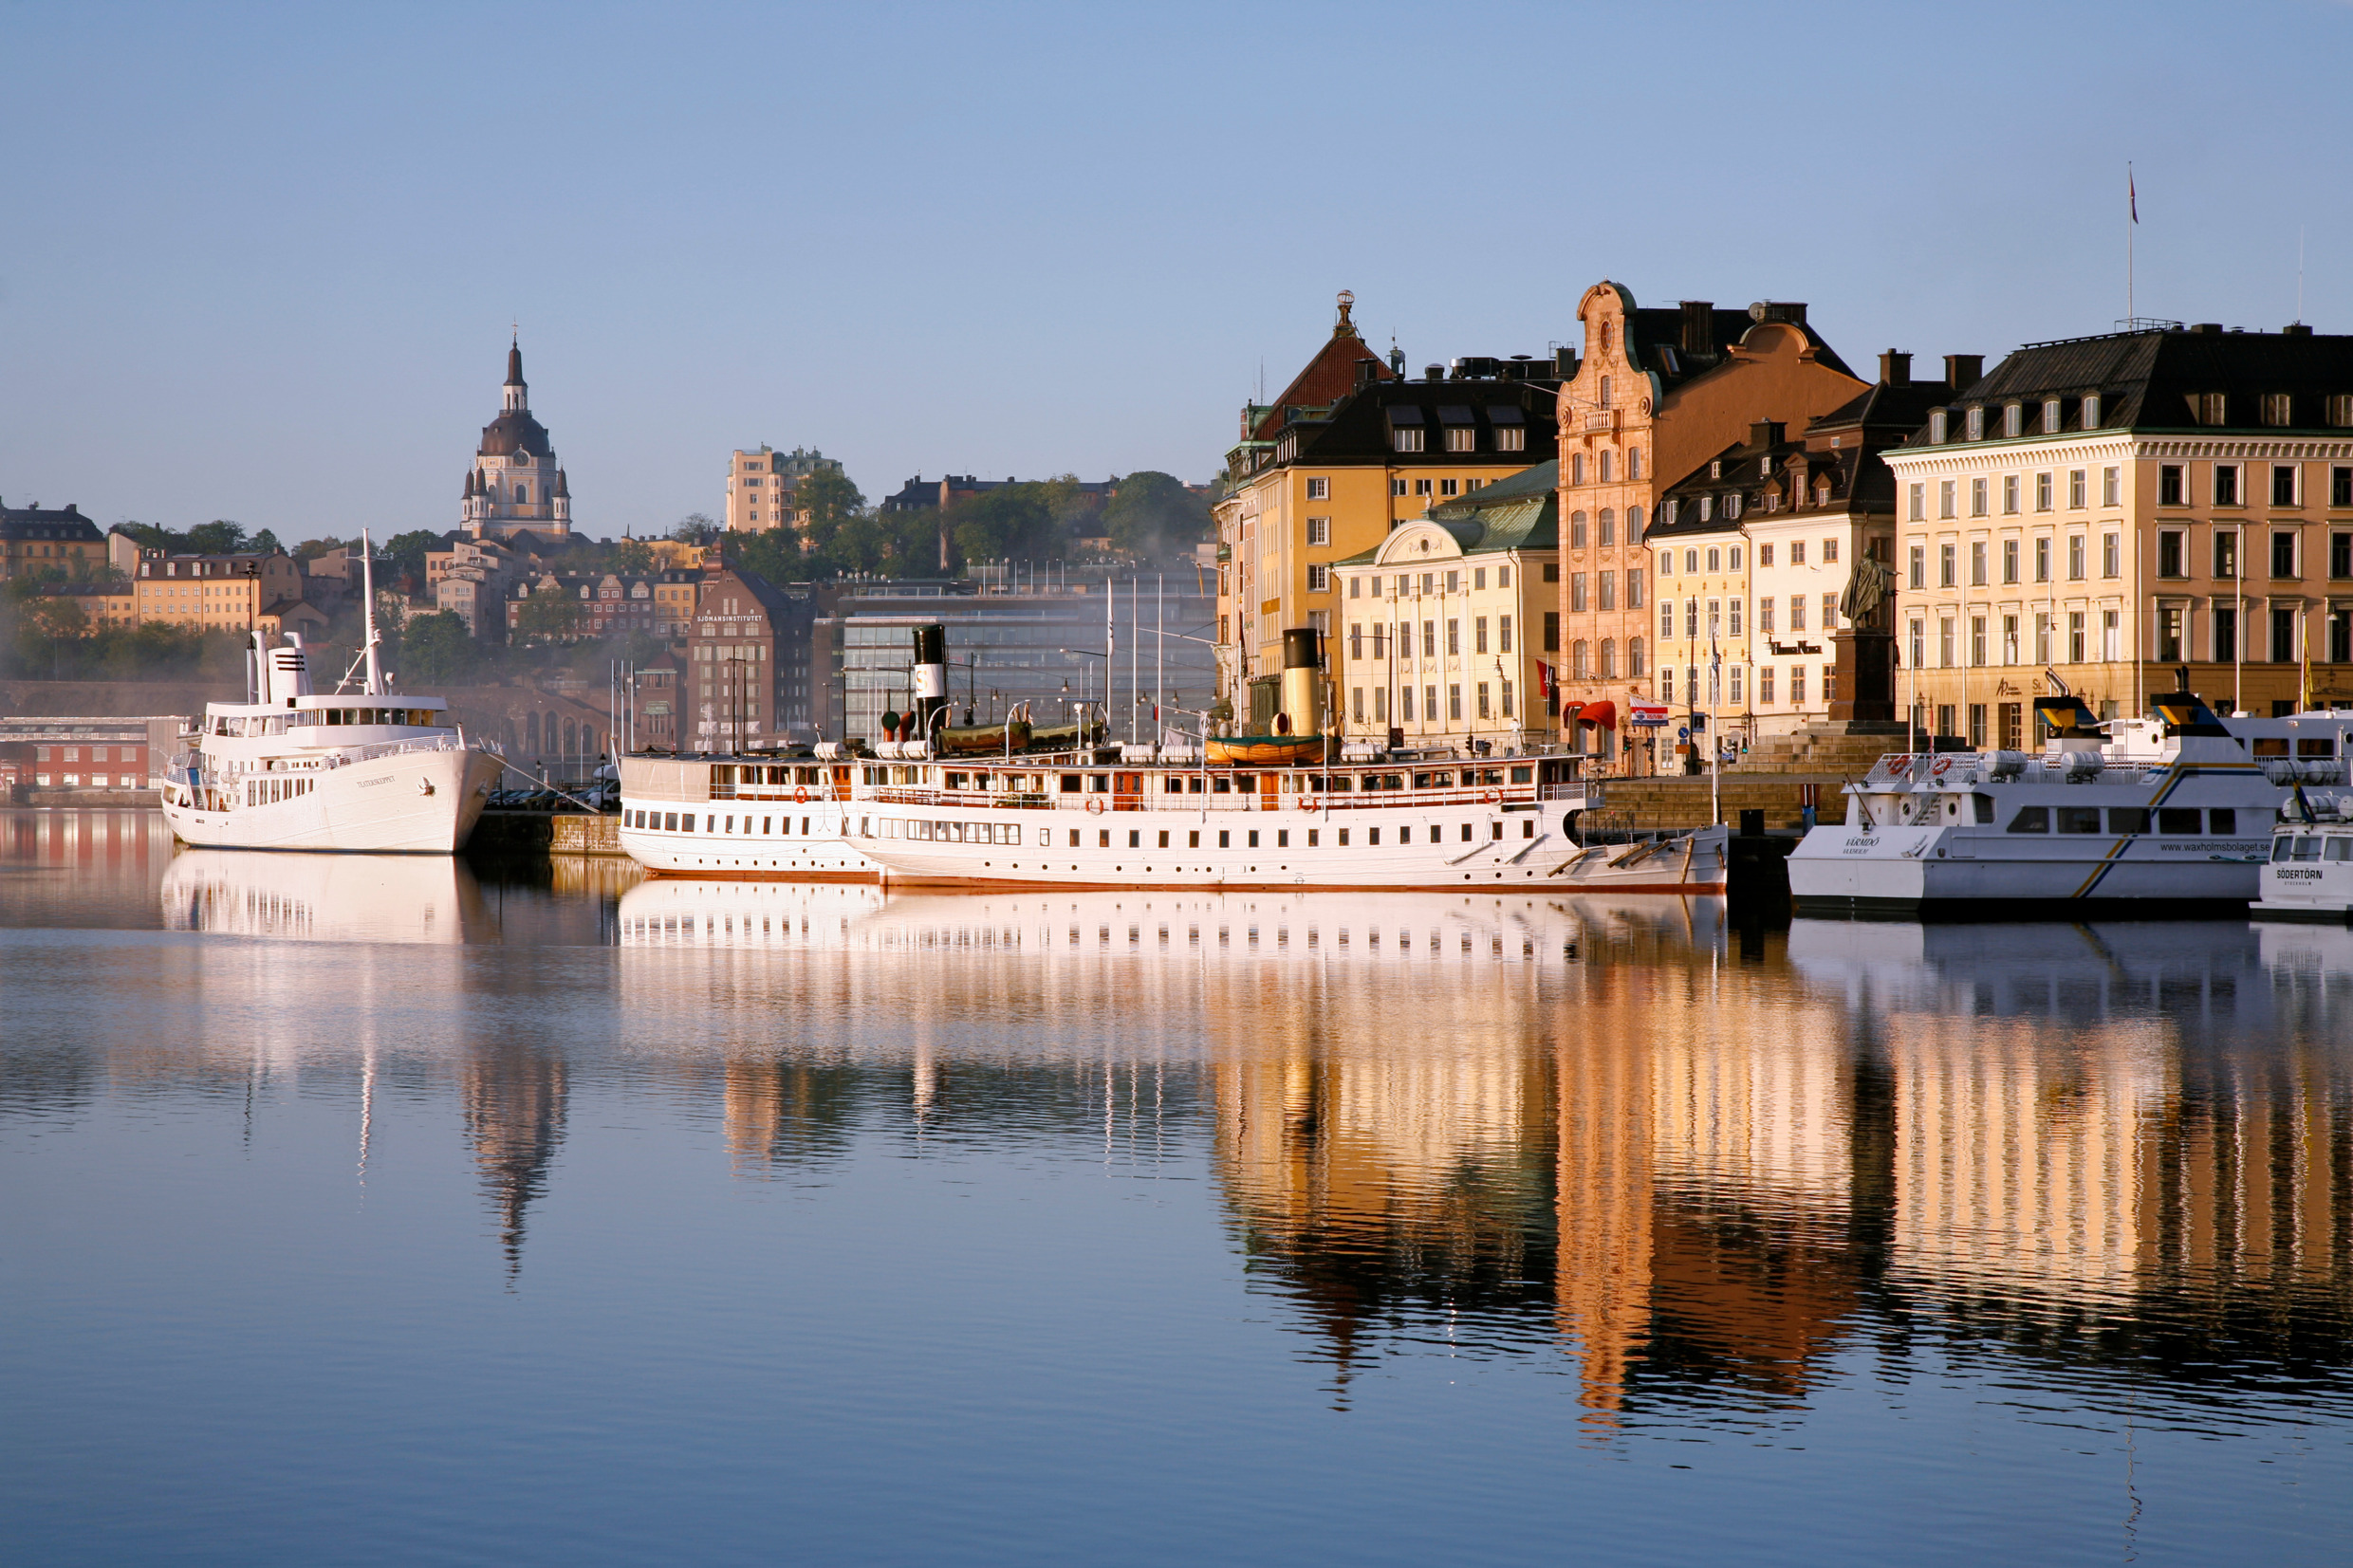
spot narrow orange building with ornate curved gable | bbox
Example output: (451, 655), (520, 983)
(1558, 282), (1863, 771)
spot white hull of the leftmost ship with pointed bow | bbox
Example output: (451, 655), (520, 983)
(160, 747), (504, 856)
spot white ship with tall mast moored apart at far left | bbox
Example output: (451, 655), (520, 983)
(160, 633), (506, 856)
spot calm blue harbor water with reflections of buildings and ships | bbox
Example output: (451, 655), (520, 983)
(0, 811), (2353, 1563)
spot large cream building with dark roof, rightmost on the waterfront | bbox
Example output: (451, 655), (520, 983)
(1884, 323), (2353, 747)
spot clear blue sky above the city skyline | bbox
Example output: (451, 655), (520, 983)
(0, 0), (2353, 541)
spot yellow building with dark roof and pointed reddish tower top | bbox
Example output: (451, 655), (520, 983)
(1212, 294), (1567, 727)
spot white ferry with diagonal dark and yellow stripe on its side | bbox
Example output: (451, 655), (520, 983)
(1788, 693), (2353, 919)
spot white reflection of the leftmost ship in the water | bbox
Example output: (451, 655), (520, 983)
(162, 849), (491, 943)
